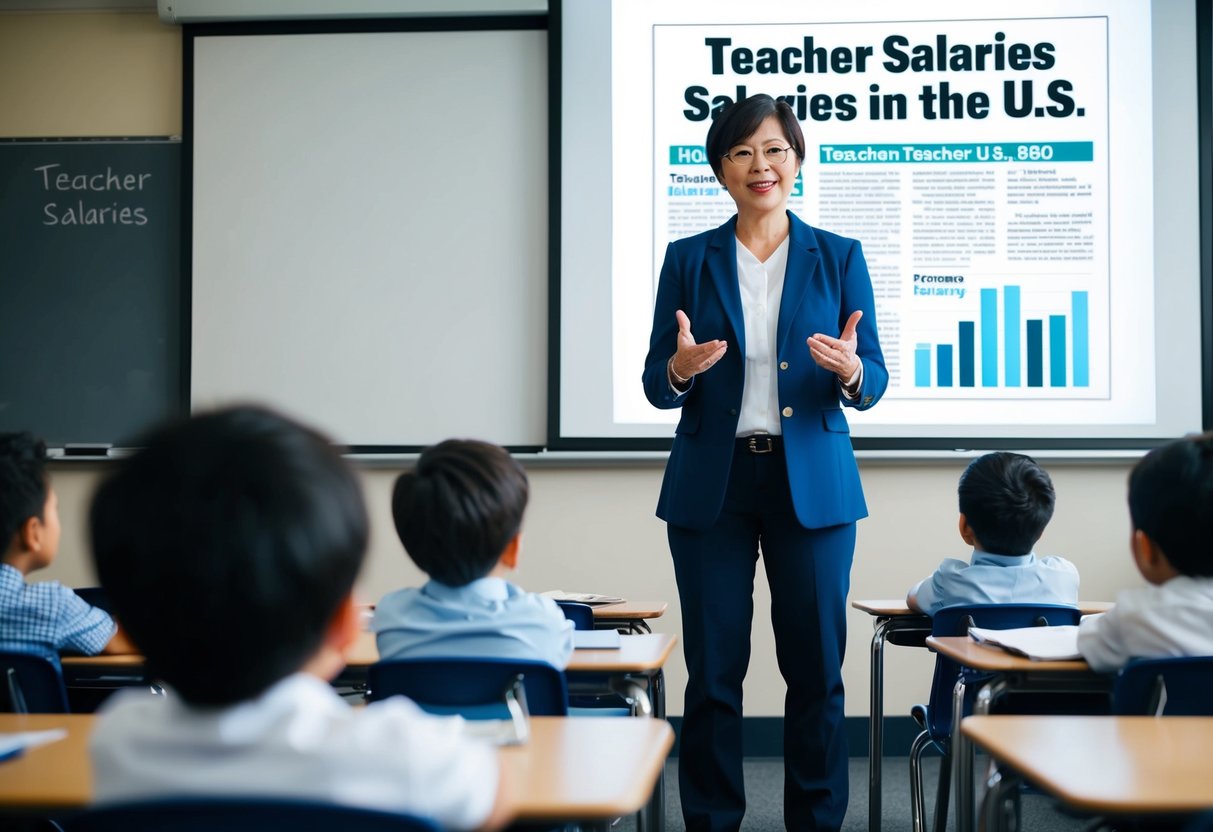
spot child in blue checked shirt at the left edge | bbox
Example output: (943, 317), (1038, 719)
(0, 433), (132, 662)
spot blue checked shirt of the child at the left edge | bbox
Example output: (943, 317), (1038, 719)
(0, 564), (118, 665)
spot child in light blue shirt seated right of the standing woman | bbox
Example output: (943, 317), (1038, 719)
(906, 451), (1078, 615)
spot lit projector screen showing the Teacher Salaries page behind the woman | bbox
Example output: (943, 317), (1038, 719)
(549, 0), (1209, 449)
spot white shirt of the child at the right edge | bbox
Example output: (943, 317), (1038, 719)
(1078, 575), (1213, 672)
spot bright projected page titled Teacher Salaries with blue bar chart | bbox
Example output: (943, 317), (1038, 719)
(611, 0), (1156, 429)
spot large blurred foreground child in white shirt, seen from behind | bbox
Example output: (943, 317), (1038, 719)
(90, 408), (508, 830)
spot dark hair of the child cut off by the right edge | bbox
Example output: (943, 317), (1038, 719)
(1129, 432), (1213, 577)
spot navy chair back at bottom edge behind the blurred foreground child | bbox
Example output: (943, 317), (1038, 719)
(62, 798), (439, 832)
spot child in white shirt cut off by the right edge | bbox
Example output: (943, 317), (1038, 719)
(1078, 433), (1213, 672)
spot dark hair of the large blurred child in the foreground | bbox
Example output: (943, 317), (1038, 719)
(90, 406), (369, 707)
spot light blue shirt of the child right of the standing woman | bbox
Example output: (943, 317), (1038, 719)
(910, 549), (1078, 615)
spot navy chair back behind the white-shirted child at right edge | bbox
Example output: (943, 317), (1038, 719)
(1112, 656), (1213, 717)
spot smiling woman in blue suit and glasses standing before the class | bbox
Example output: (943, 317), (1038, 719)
(644, 95), (888, 832)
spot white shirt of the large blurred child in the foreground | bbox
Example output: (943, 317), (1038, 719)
(90, 673), (497, 830)
